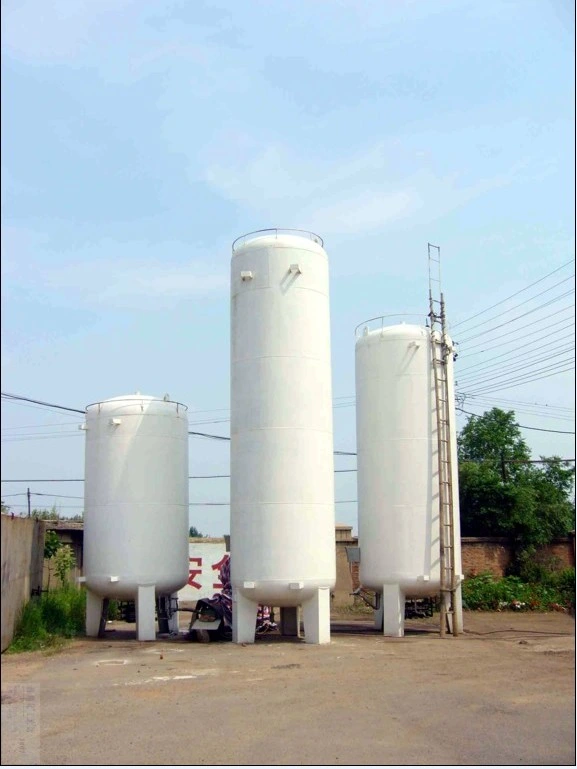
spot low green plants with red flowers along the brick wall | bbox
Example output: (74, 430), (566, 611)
(463, 569), (575, 611)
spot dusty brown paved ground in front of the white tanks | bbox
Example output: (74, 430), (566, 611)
(2, 613), (575, 766)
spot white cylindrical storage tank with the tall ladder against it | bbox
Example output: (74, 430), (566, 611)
(356, 319), (462, 636)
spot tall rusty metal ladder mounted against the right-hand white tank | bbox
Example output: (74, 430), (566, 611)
(427, 243), (458, 637)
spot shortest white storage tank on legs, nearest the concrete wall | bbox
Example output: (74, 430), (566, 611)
(84, 393), (188, 640)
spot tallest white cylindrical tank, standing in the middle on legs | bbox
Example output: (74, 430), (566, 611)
(231, 230), (336, 643)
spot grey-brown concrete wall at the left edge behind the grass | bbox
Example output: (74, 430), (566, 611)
(1, 515), (44, 651)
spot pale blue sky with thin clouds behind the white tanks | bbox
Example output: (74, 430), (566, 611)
(2, 0), (575, 535)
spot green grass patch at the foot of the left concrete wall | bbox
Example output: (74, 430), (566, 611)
(6, 587), (86, 654)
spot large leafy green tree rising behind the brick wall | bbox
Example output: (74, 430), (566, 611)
(458, 408), (575, 553)
